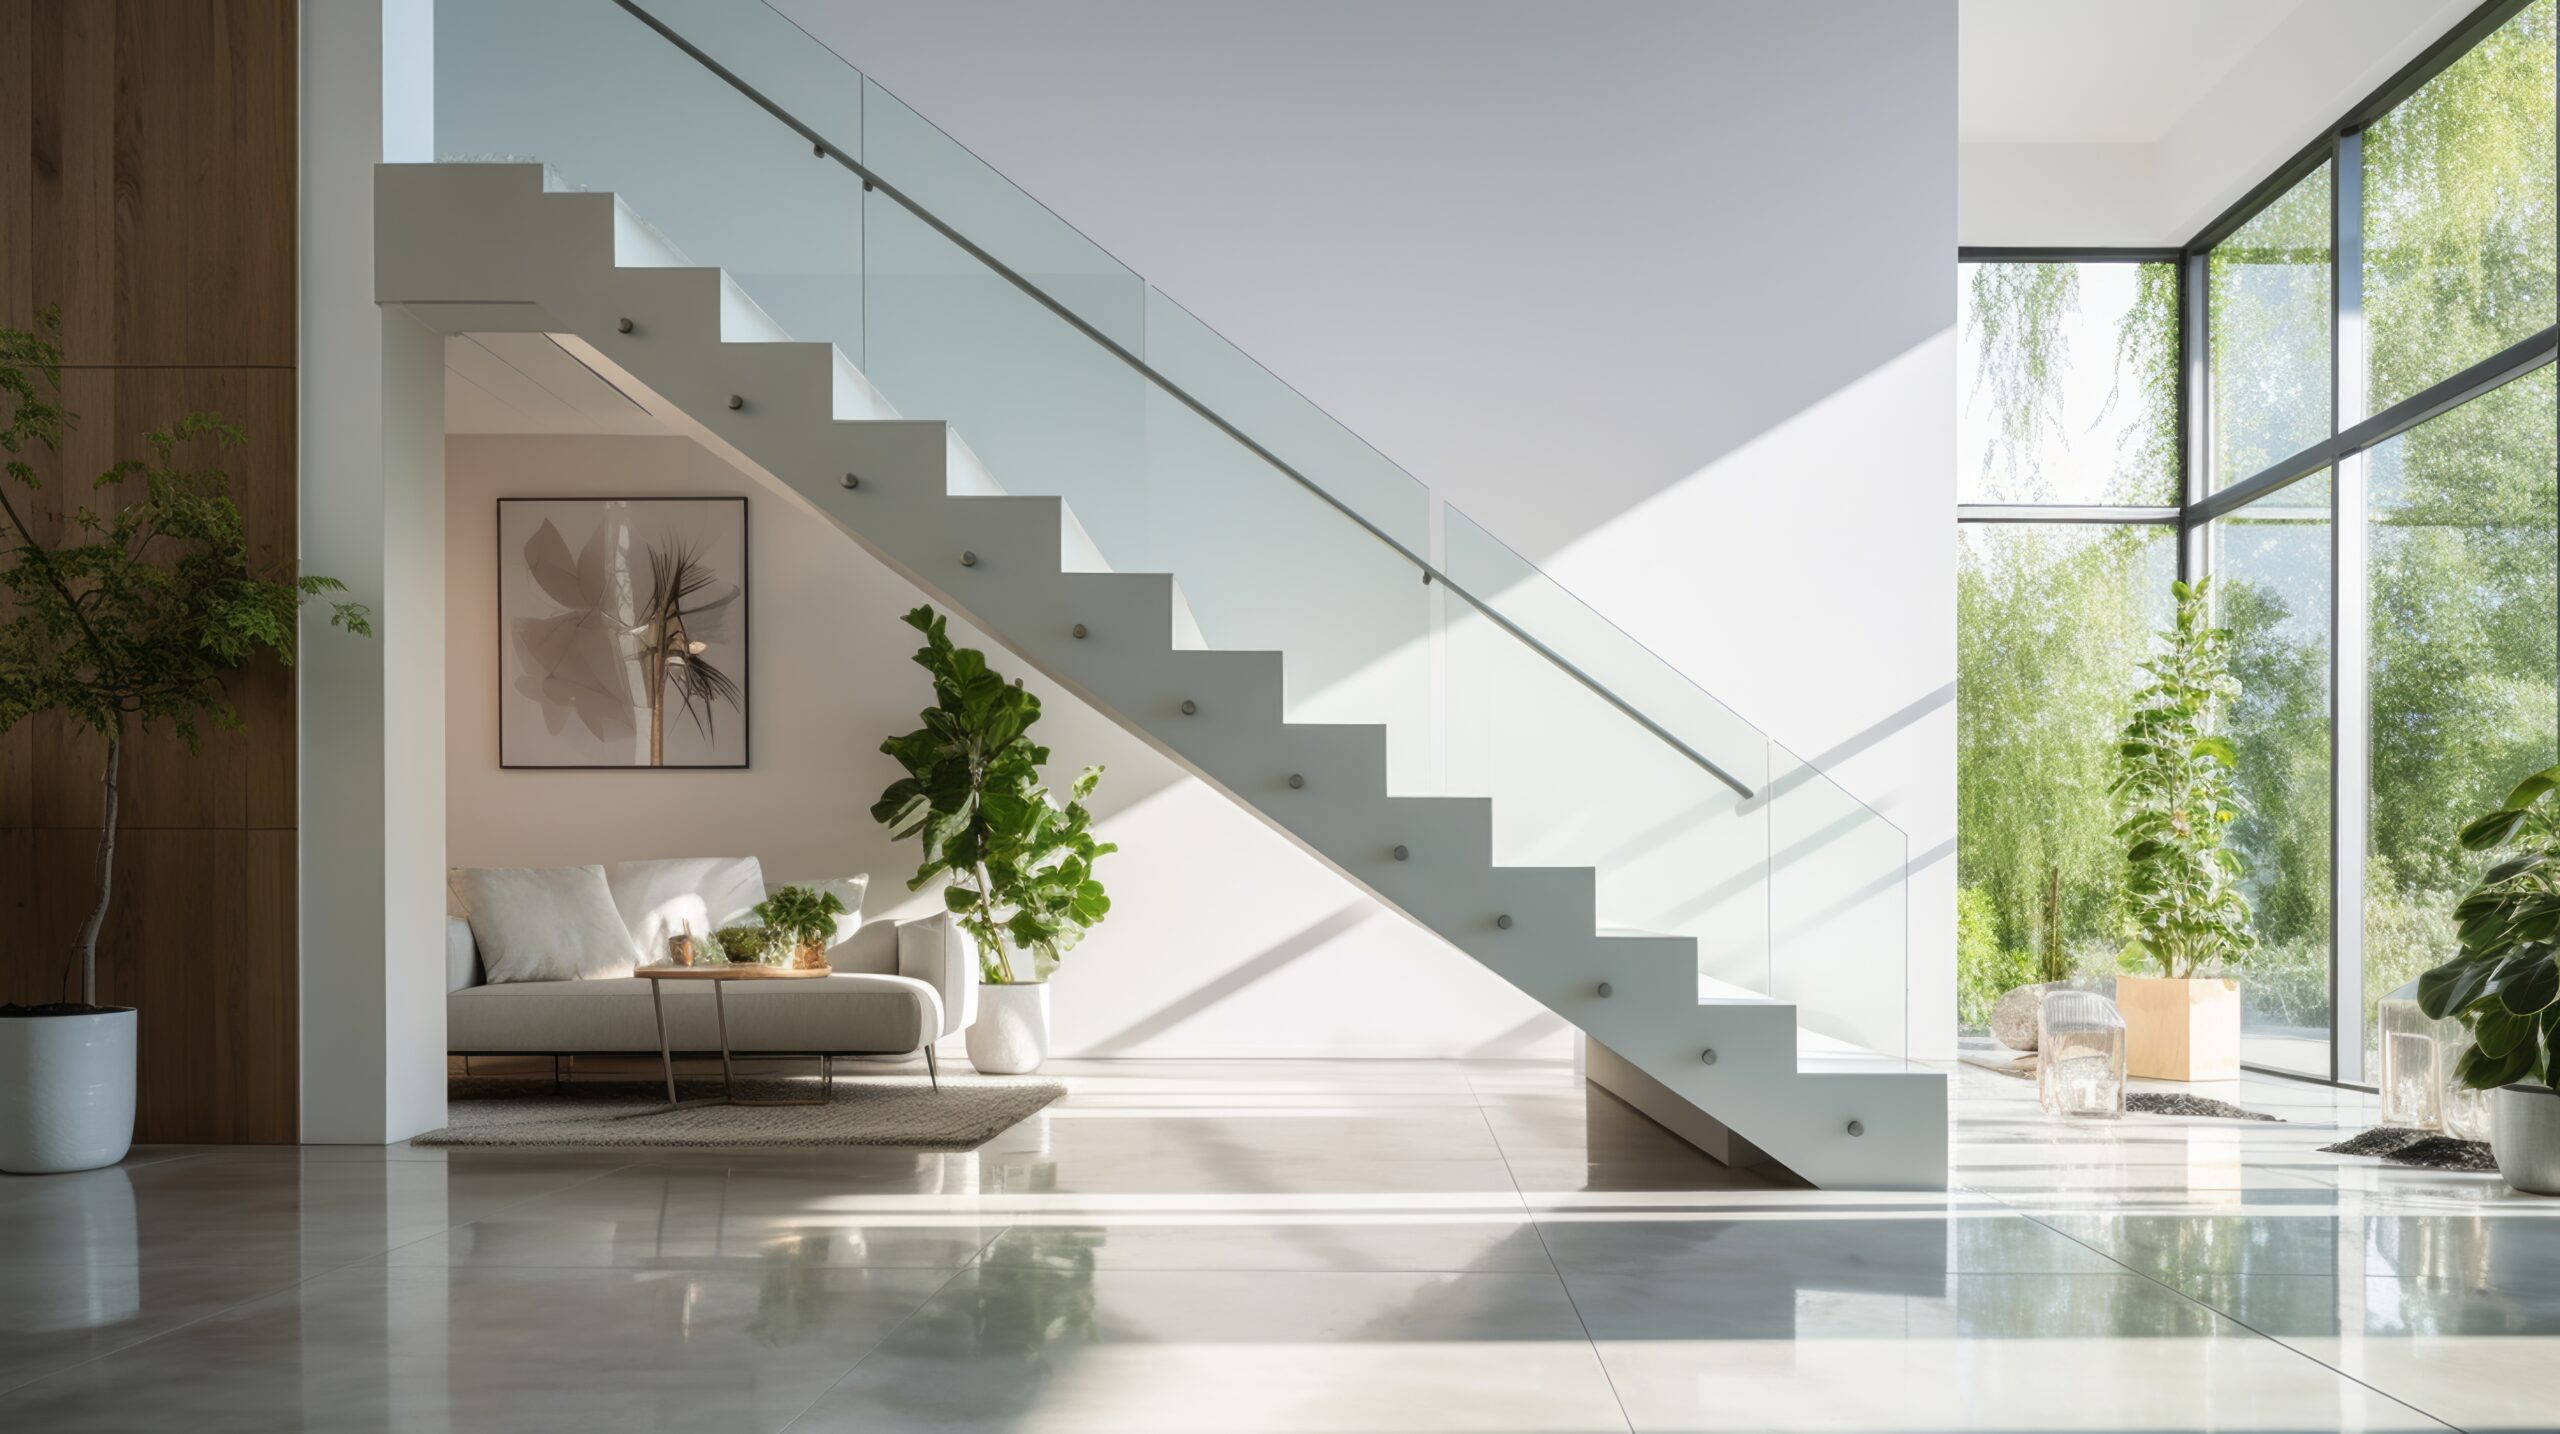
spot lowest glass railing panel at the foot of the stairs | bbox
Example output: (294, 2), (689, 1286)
(1766, 743), (1910, 1058)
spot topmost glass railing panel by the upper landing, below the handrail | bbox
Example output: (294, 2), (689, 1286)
(435, 0), (863, 361)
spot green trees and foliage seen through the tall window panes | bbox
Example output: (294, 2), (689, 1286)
(1956, 0), (2560, 1055)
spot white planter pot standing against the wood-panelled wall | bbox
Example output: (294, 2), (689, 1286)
(0, 1006), (133, 1175)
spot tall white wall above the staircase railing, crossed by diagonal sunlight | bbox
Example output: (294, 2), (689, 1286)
(757, 0), (1956, 1052)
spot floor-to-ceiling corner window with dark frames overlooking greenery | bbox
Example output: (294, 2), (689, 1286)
(1958, 0), (2560, 1081)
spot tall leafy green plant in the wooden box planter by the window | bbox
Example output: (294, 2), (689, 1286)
(2107, 579), (2258, 978)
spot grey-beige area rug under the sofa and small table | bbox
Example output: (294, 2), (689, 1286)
(412, 1073), (1068, 1150)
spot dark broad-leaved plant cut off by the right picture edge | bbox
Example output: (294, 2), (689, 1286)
(2417, 766), (2560, 1091)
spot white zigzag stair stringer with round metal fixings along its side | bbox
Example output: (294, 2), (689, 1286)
(374, 164), (1946, 1188)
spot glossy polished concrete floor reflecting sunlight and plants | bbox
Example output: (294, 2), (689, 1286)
(0, 1060), (2560, 1434)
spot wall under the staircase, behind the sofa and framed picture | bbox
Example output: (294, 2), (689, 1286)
(445, 435), (1569, 1058)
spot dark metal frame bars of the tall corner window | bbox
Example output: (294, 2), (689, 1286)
(1956, 0), (2560, 1088)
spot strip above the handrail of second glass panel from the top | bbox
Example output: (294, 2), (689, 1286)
(855, 80), (1147, 353)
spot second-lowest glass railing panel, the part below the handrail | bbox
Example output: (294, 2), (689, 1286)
(1441, 597), (1772, 994)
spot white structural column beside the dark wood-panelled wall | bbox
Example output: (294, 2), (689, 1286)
(300, 0), (445, 1145)
